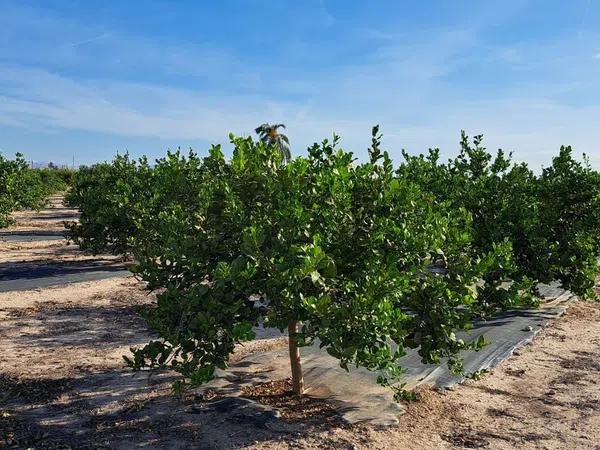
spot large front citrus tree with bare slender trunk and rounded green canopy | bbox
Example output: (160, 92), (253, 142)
(127, 128), (510, 393)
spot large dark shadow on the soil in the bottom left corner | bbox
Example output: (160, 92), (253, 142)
(0, 370), (364, 449)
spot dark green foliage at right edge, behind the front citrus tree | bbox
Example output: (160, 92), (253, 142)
(398, 132), (600, 301)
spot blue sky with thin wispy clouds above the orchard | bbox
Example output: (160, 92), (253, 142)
(0, 0), (600, 167)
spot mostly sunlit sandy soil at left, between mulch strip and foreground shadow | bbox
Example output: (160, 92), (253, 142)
(0, 278), (157, 378)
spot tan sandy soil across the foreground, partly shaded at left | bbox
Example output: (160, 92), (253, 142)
(0, 199), (600, 450)
